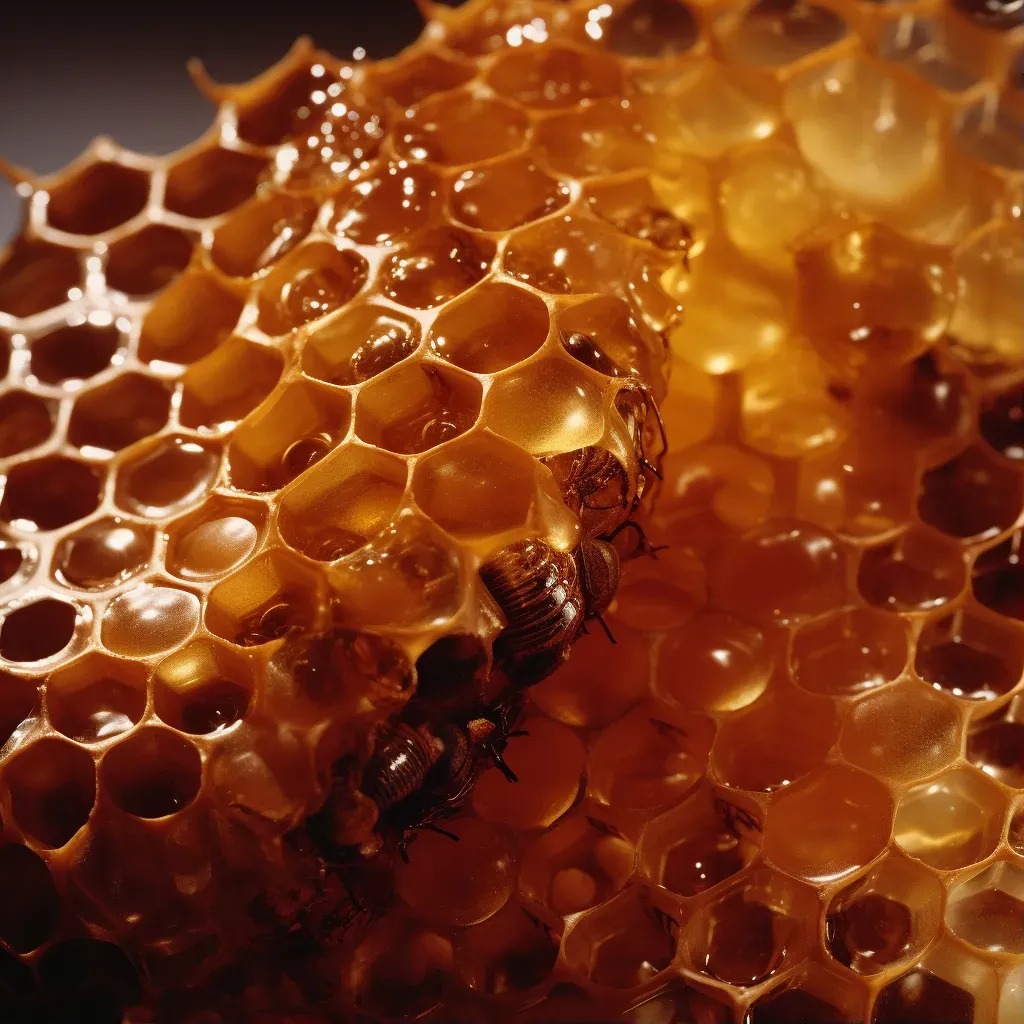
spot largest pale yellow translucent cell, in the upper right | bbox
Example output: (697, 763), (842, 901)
(784, 56), (940, 207)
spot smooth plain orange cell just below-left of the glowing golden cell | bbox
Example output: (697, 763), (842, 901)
(413, 433), (538, 538)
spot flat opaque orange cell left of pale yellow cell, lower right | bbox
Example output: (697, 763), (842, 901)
(764, 766), (893, 883)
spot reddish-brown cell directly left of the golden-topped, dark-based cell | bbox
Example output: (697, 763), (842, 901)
(46, 653), (147, 743)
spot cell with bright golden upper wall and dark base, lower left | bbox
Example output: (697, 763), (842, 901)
(154, 640), (256, 736)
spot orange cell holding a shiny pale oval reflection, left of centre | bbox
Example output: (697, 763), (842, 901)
(164, 495), (267, 581)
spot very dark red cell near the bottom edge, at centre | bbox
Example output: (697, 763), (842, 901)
(455, 901), (561, 995)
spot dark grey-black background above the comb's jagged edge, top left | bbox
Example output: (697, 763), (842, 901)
(0, 0), (456, 245)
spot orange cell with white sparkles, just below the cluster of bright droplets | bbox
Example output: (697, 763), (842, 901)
(330, 161), (443, 246)
